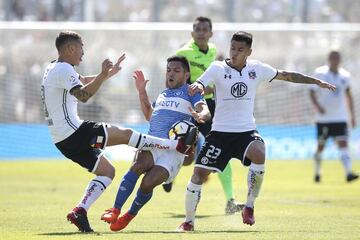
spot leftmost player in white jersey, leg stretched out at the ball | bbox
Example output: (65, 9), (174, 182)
(41, 31), (197, 232)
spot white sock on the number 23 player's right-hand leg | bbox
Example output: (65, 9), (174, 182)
(245, 163), (265, 208)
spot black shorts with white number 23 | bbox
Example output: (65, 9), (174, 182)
(195, 130), (264, 172)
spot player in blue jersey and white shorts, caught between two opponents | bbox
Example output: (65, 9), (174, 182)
(101, 56), (211, 231)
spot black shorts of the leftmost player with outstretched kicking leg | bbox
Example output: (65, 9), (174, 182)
(55, 121), (109, 172)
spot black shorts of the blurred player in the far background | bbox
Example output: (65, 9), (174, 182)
(316, 122), (348, 142)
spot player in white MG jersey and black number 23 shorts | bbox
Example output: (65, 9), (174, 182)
(177, 32), (335, 231)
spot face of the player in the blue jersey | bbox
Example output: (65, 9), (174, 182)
(166, 61), (189, 88)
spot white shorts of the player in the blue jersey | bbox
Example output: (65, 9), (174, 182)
(150, 149), (185, 183)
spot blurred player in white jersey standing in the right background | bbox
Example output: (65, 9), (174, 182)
(310, 51), (359, 182)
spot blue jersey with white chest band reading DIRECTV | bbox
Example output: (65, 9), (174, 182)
(148, 84), (205, 138)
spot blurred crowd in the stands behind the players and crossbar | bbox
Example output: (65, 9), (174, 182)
(0, 0), (360, 124)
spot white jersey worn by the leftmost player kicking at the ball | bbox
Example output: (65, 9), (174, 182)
(41, 61), (82, 143)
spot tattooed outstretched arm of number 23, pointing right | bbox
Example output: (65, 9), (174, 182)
(275, 70), (336, 91)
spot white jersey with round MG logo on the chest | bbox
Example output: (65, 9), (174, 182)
(197, 60), (277, 132)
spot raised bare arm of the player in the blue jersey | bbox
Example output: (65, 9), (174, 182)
(133, 70), (153, 121)
